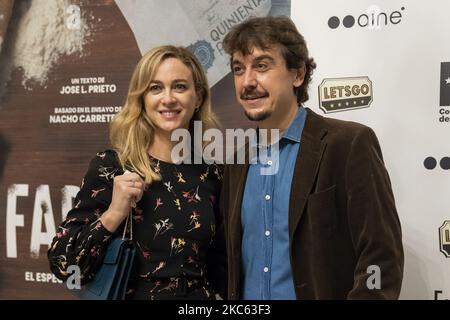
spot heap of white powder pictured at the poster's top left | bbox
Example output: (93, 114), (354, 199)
(12, 0), (89, 87)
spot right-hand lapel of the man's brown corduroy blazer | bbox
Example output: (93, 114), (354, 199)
(289, 108), (327, 243)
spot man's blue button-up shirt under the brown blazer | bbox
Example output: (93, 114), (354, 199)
(241, 107), (306, 300)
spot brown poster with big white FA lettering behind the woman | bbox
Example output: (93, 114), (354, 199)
(0, 0), (290, 299)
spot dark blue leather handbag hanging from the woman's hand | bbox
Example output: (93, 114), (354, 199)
(79, 214), (136, 300)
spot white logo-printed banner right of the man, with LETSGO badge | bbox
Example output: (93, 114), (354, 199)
(291, 0), (450, 299)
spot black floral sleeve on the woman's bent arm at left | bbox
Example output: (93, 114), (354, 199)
(47, 151), (122, 284)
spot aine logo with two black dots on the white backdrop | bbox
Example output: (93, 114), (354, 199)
(328, 5), (405, 29)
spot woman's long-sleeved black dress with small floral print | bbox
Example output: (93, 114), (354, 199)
(48, 150), (227, 299)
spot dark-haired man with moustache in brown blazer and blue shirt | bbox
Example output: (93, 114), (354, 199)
(221, 17), (403, 299)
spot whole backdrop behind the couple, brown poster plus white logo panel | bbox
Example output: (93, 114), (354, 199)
(0, 0), (450, 299)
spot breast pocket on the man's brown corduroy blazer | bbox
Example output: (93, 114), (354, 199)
(306, 185), (336, 229)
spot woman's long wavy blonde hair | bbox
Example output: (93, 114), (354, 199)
(110, 45), (219, 184)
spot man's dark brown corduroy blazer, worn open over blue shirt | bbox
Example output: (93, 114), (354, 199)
(221, 109), (404, 299)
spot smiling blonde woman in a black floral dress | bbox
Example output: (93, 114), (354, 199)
(48, 46), (226, 299)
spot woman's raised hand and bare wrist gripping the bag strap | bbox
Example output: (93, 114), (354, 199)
(100, 171), (145, 232)
